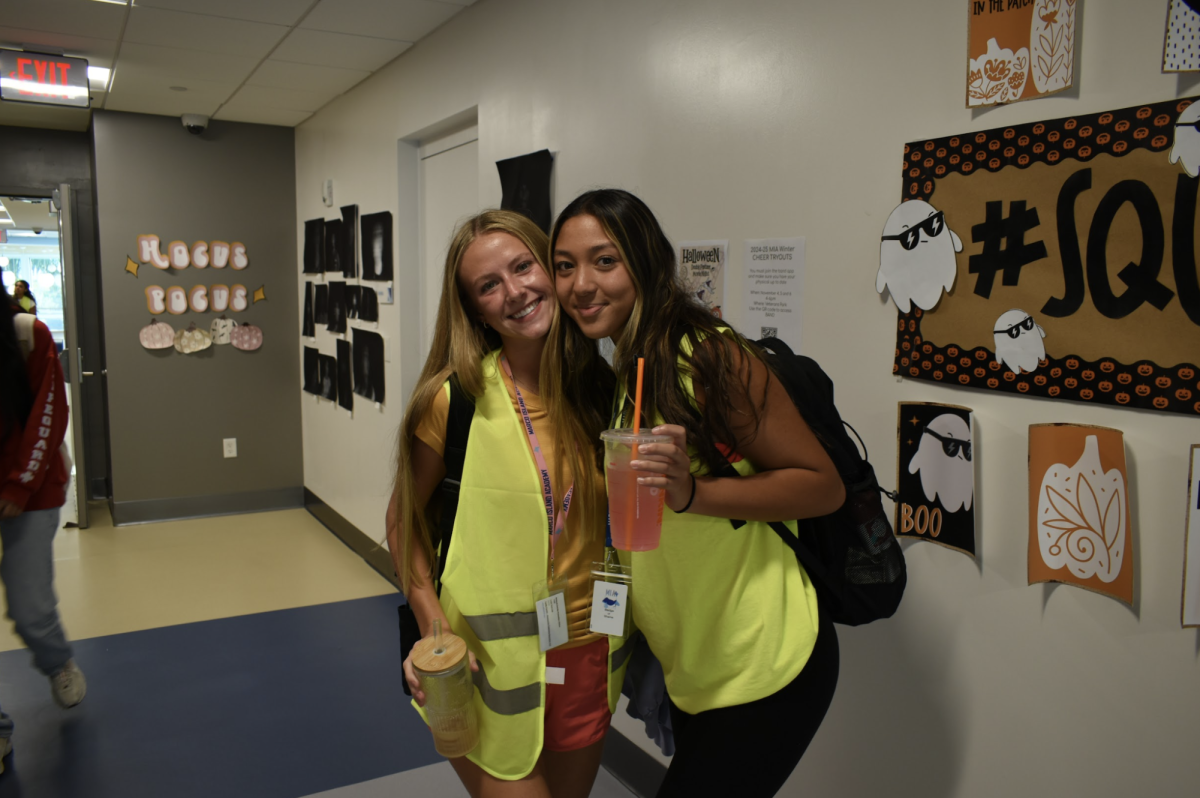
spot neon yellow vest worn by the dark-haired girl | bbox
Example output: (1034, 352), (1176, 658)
(617, 340), (818, 714)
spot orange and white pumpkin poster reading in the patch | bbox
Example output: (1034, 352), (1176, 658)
(967, 0), (1081, 108)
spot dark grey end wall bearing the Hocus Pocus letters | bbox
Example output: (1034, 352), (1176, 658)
(92, 112), (304, 523)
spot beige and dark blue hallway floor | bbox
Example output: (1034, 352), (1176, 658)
(0, 505), (631, 798)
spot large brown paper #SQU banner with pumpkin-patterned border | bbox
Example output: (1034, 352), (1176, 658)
(880, 98), (1200, 415)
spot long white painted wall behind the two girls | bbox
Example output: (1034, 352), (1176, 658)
(296, 0), (1200, 798)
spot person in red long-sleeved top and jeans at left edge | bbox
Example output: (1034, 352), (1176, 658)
(0, 276), (86, 773)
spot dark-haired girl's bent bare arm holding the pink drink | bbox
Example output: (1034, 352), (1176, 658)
(636, 342), (846, 521)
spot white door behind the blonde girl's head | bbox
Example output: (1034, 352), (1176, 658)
(419, 127), (480, 361)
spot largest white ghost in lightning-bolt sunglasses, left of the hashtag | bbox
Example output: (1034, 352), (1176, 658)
(875, 199), (962, 313)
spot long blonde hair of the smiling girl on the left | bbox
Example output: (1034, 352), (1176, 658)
(394, 210), (598, 590)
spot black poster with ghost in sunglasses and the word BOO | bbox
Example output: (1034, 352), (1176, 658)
(894, 402), (976, 557)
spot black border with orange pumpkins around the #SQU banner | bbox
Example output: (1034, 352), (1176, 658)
(892, 97), (1200, 415)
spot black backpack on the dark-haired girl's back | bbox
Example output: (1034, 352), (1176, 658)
(718, 338), (908, 626)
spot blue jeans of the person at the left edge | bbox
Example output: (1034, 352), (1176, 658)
(0, 508), (71, 737)
